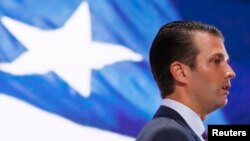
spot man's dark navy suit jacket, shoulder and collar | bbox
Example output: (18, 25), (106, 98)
(136, 106), (201, 141)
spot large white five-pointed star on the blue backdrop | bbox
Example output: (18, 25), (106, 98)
(1, 2), (142, 96)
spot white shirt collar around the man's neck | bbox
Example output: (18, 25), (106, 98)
(162, 99), (205, 141)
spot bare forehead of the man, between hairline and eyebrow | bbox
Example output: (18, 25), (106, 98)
(193, 32), (229, 59)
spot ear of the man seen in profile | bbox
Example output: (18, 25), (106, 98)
(170, 61), (188, 83)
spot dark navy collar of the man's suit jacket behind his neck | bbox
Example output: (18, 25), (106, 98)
(154, 106), (200, 141)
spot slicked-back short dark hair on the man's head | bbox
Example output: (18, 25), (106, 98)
(149, 21), (224, 98)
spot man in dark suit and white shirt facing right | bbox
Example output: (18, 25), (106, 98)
(136, 21), (235, 141)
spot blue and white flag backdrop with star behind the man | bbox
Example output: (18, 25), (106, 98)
(0, 0), (250, 141)
